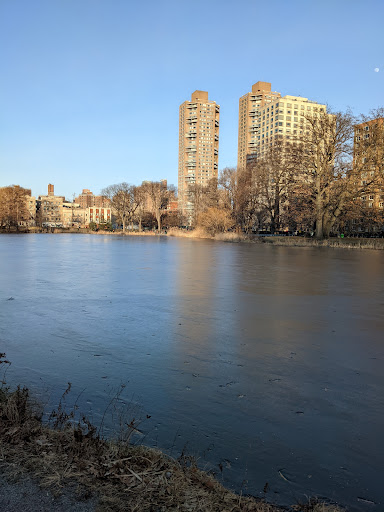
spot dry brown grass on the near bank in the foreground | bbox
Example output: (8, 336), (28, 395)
(0, 354), (341, 512)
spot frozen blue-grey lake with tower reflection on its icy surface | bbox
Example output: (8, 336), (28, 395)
(0, 234), (384, 512)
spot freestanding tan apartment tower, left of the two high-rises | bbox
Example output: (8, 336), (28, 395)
(178, 91), (220, 216)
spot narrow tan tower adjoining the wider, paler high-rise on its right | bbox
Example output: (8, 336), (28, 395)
(237, 82), (280, 169)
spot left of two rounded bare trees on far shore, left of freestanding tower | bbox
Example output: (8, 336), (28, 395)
(101, 182), (140, 231)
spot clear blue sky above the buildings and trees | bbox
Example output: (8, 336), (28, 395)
(0, 0), (384, 199)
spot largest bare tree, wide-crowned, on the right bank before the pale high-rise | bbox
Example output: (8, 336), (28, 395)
(297, 108), (384, 239)
